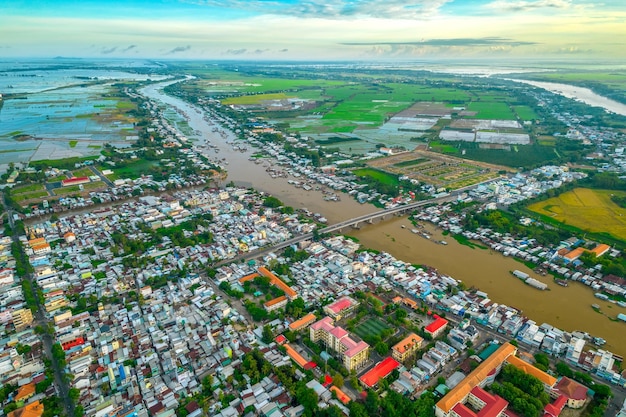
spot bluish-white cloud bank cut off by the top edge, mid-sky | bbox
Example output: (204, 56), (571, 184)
(189, 0), (448, 19)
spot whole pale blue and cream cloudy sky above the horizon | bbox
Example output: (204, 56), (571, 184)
(0, 0), (626, 62)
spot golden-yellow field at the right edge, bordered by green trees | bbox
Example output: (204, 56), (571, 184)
(527, 188), (626, 241)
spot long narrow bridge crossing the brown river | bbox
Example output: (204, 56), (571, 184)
(215, 191), (459, 268)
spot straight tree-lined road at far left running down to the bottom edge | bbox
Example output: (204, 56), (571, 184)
(0, 193), (74, 416)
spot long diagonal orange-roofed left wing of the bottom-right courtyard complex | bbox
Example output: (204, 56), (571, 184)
(435, 343), (517, 417)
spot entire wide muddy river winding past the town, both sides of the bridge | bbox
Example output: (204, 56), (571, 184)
(141, 82), (626, 356)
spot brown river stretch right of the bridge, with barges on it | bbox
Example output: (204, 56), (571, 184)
(347, 217), (626, 355)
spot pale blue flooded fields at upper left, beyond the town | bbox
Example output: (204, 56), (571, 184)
(0, 63), (163, 165)
